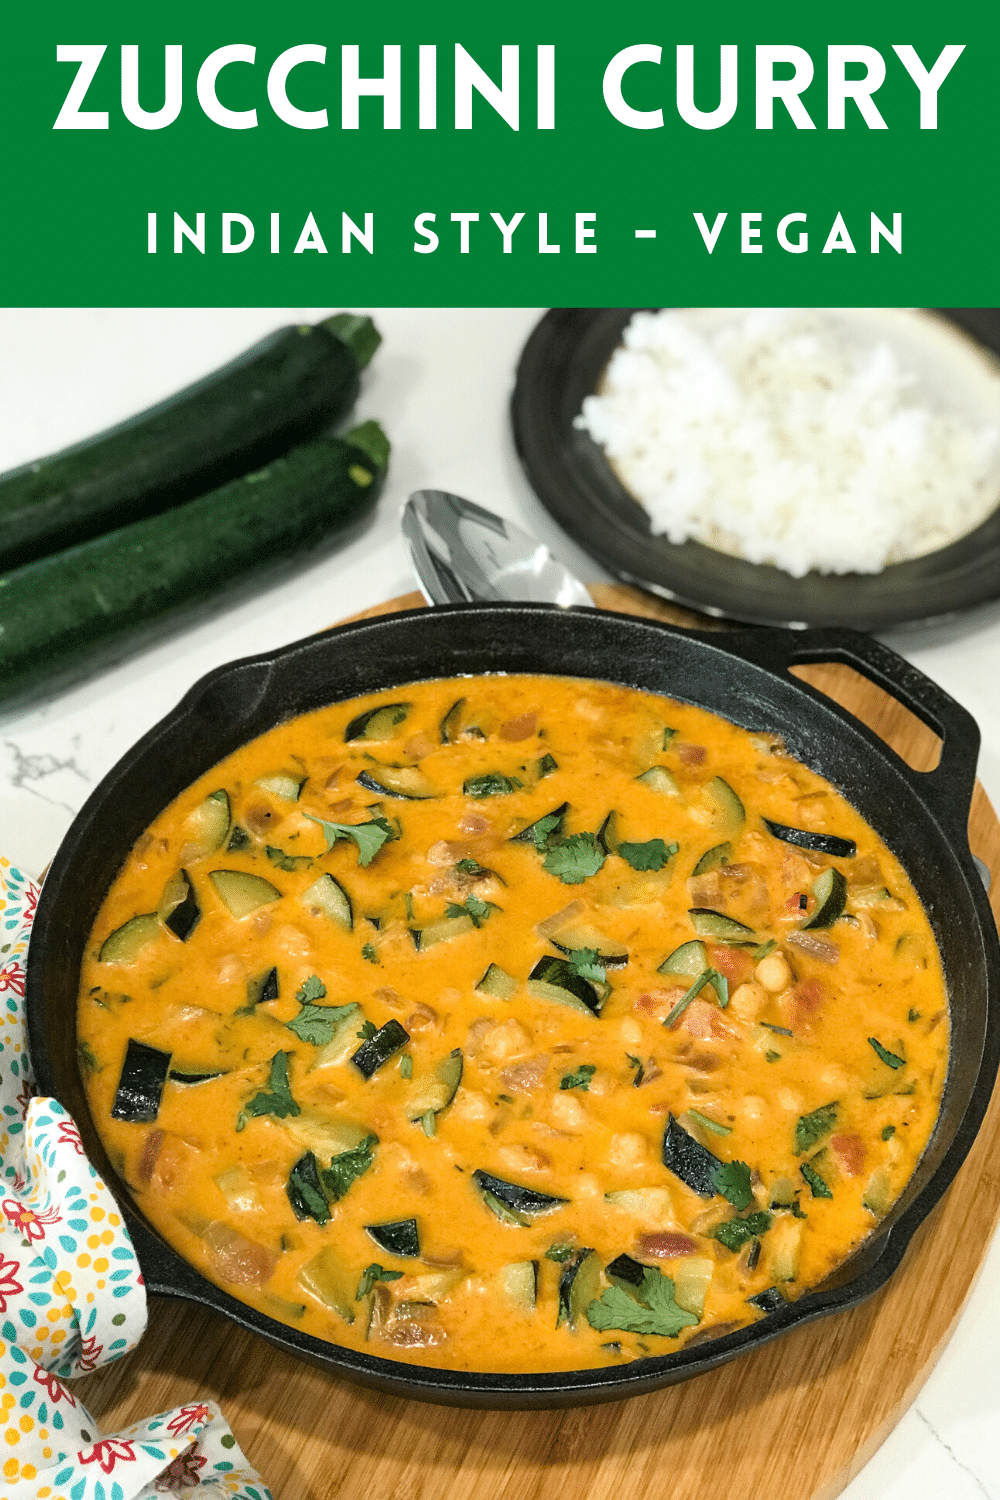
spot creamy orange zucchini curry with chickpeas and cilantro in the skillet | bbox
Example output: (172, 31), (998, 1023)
(78, 675), (949, 1371)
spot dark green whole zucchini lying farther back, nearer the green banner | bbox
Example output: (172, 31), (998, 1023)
(0, 314), (379, 570)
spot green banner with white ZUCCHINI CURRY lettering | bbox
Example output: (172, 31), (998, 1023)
(0, 0), (1000, 306)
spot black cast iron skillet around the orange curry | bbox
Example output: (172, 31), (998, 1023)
(27, 605), (1000, 1407)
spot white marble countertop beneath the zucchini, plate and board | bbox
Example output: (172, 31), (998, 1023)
(0, 308), (1000, 1500)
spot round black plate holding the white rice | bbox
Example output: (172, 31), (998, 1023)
(511, 308), (1000, 630)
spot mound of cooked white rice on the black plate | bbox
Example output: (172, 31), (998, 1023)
(577, 308), (1000, 578)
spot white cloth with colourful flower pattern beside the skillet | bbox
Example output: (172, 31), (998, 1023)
(0, 857), (270, 1500)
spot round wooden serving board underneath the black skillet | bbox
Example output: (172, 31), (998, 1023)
(76, 585), (1000, 1500)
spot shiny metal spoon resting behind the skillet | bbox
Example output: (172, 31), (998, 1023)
(400, 489), (594, 608)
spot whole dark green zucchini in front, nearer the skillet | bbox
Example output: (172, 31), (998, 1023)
(0, 422), (388, 702)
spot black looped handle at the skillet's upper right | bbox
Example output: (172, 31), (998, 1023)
(714, 629), (979, 848)
